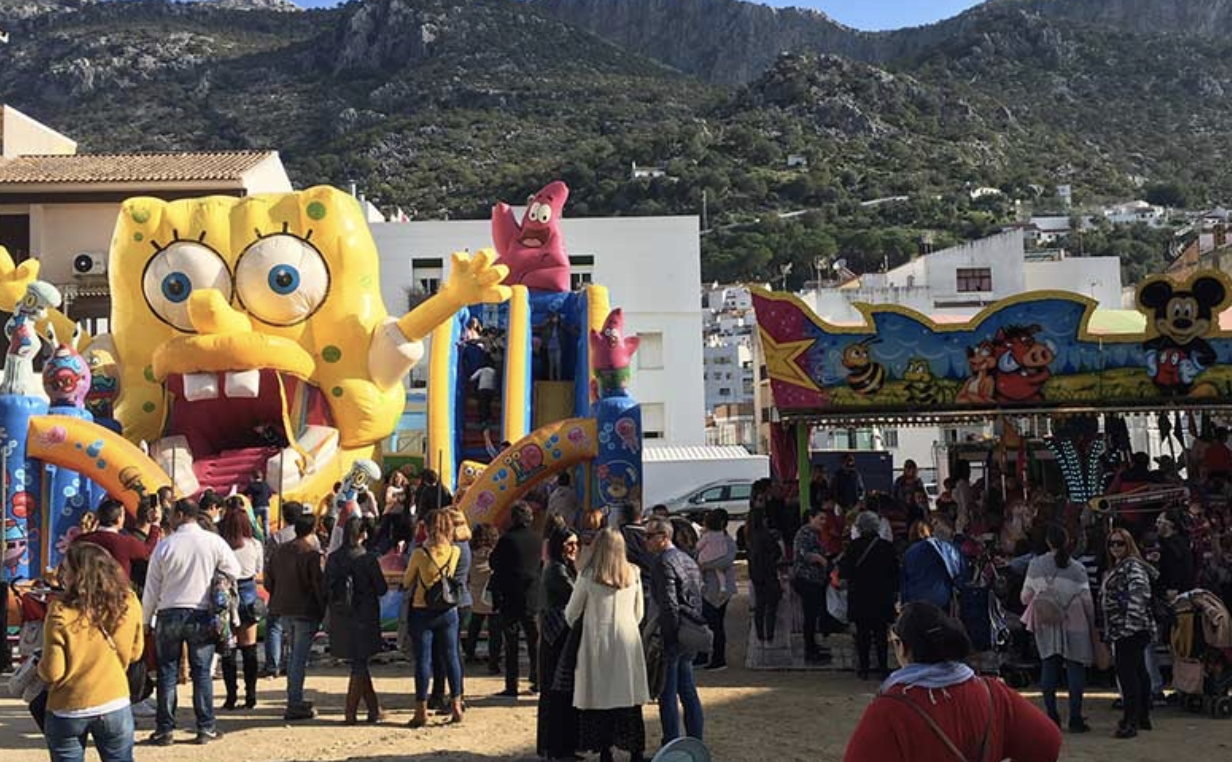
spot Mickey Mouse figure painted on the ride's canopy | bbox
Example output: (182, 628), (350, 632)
(1138, 276), (1232, 396)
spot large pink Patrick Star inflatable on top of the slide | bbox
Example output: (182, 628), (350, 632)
(492, 180), (570, 292)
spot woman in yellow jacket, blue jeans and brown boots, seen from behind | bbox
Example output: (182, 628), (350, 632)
(402, 510), (464, 728)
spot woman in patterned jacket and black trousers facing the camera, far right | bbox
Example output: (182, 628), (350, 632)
(1099, 527), (1154, 739)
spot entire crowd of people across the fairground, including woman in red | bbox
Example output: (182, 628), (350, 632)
(14, 418), (1232, 762)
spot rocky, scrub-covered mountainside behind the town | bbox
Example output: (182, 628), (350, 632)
(7, 0), (1232, 285)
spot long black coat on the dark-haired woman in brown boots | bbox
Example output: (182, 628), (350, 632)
(325, 548), (389, 659)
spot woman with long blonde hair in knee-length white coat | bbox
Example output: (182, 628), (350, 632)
(564, 529), (650, 762)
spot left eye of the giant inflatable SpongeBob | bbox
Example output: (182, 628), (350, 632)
(142, 241), (232, 332)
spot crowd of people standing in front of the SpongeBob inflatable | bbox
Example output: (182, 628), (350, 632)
(4, 457), (719, 762)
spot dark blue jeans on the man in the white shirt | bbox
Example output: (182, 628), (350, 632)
(154, 608), (214, 734)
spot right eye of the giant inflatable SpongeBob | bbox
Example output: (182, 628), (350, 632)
(235, 233), (329, 325)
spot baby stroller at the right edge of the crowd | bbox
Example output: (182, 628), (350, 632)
(1172, 590), (1232, 719)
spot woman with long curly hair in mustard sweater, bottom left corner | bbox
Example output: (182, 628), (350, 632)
(38, 543), (144, 762)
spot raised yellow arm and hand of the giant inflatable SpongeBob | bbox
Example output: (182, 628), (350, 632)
(368, 249), (511, 389)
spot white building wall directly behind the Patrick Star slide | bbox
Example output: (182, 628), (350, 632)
(372, 217), (705, 444)
